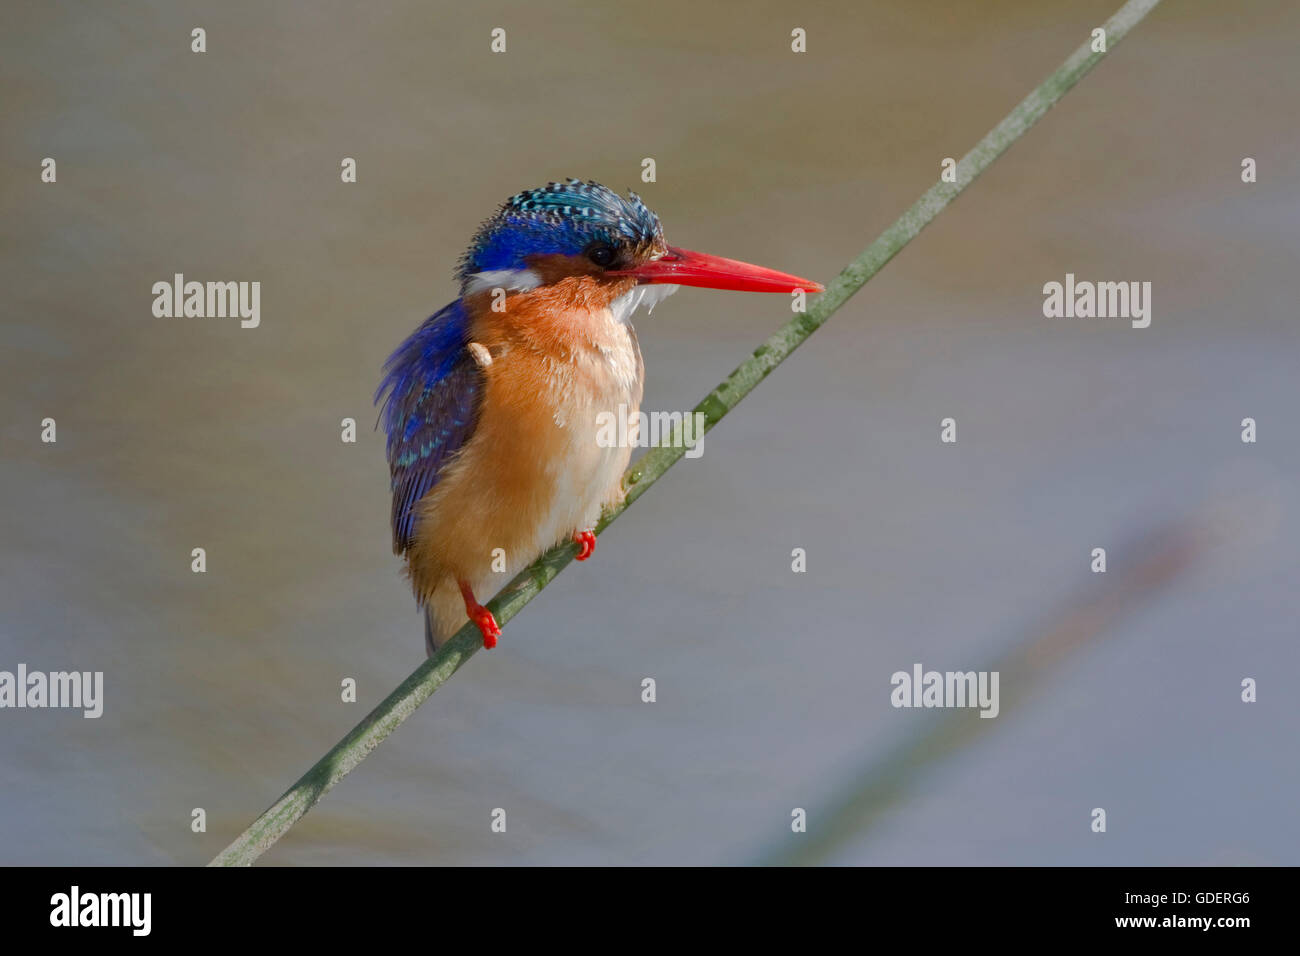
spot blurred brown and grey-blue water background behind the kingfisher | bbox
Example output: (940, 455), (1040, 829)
(0, 0), (1300, 865)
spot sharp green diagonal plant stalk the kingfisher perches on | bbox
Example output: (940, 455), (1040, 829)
(209, 0), (1160, 866)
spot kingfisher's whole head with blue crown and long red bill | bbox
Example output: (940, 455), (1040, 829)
(456, 179), (822, 317)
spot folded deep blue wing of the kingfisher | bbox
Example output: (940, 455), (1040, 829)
(374, 299), (482, 554)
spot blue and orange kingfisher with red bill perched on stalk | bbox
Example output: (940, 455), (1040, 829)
(374, 179), (822, 654)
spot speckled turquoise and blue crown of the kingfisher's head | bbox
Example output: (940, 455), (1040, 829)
(456, 179), (663, 285)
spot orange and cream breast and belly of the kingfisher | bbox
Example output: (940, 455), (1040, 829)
(407, 284), (642, 639)
